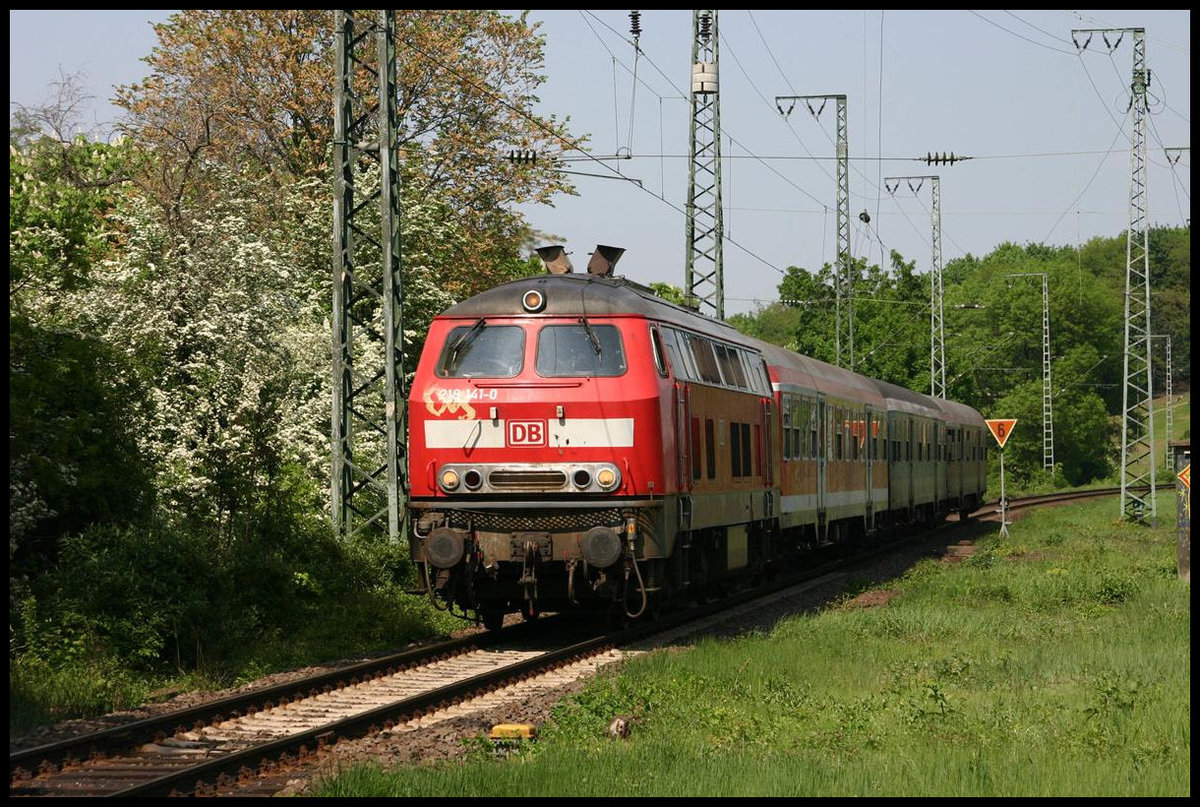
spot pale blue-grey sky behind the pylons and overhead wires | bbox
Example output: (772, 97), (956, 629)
(8, 10), (1192, 316)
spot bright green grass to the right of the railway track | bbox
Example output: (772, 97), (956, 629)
(317, 498), (1190, 796)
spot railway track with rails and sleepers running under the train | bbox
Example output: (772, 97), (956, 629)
(10, 489), (1156, 797)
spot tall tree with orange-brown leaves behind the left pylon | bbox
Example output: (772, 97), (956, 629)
(116, 10), (574, 287)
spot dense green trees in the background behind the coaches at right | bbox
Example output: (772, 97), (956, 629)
(730, 227), (1190, 490)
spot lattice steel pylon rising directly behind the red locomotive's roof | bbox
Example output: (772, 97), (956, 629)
(684, 11), (725, 319)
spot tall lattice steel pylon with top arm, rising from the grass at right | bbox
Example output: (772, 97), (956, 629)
(1070, 28), (1158, 526)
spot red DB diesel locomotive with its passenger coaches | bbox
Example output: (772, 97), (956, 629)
(407, 245), (989, 629)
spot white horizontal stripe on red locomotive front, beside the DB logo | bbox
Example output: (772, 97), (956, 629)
(425, 418), (634, 449)
